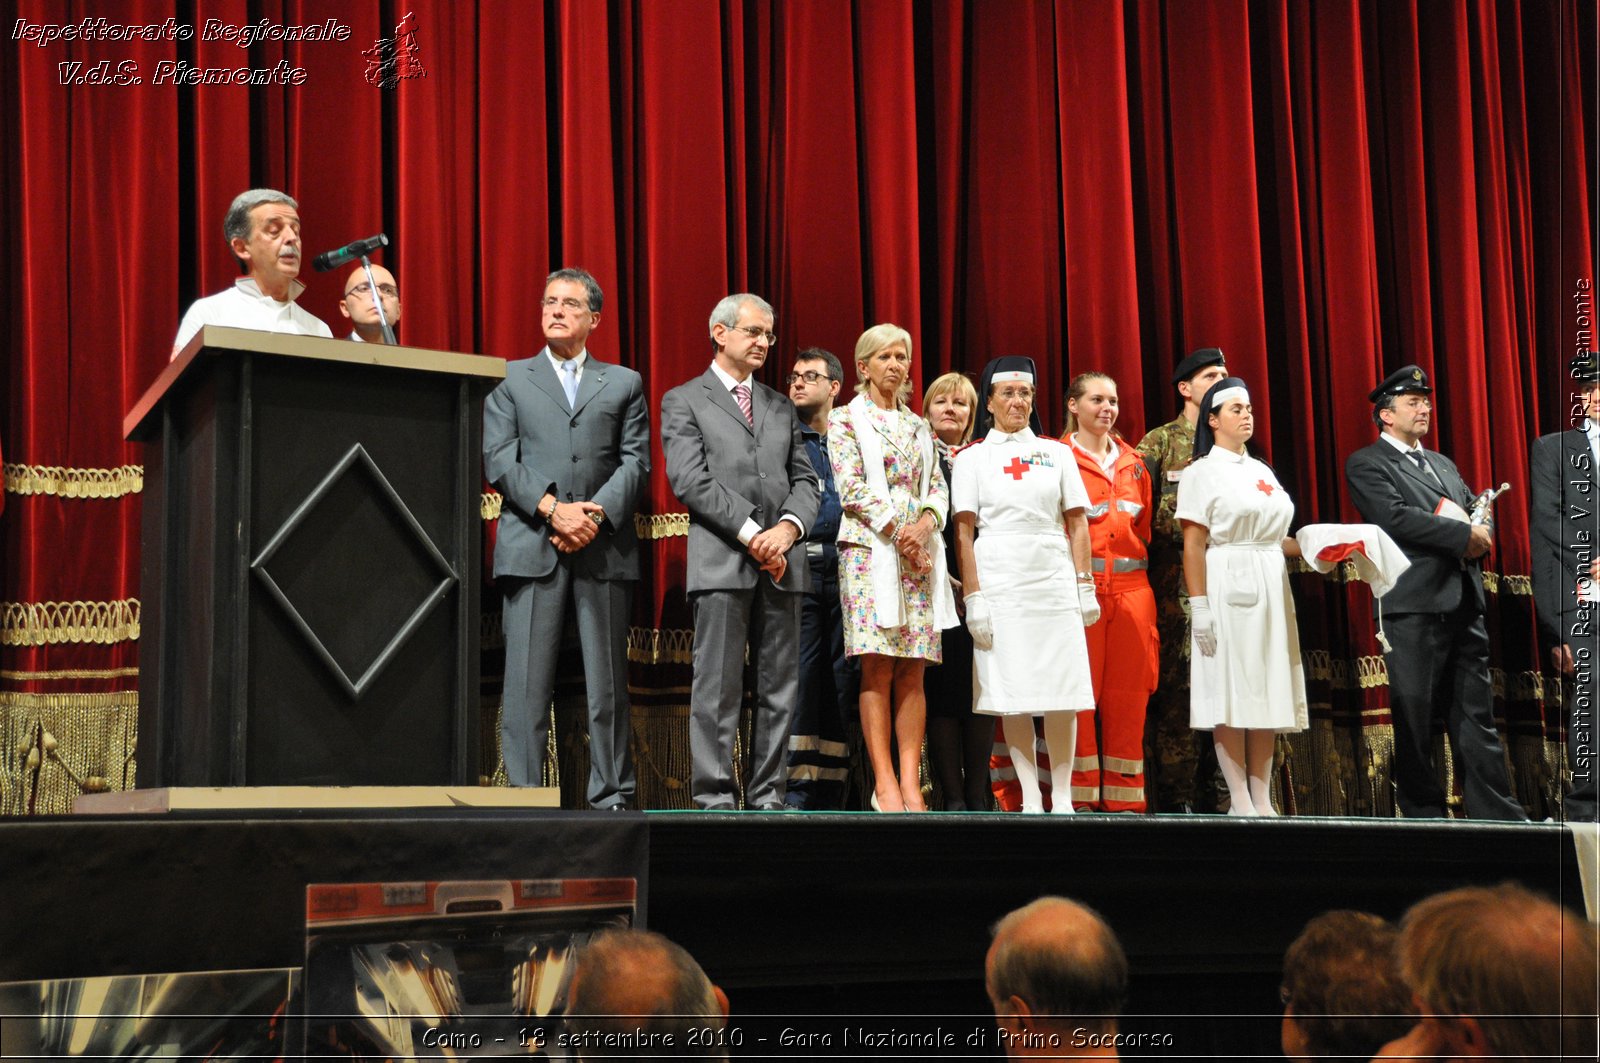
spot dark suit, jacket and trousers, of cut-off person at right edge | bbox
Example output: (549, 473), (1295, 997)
(1528, 431), (1600, 821)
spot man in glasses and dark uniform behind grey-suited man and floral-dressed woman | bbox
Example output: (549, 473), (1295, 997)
(784, 347), (861, 810)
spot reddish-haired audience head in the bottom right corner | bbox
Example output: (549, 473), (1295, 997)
(1381, 884), (1600, 1063)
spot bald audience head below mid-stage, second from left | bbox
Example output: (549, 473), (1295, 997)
(984, 897), (1128, 1058)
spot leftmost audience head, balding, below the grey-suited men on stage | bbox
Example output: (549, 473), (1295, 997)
(566, 930), (728, 1060)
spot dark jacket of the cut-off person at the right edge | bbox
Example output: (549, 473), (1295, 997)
(1528, 429), (1600, 647)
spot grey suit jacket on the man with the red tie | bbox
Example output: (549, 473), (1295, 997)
(661, 368), (819, 594)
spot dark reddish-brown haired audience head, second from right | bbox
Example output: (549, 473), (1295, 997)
(1282, 911), (1416, 1060)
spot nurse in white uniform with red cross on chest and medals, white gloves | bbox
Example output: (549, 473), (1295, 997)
(950, 357), (1099, 813)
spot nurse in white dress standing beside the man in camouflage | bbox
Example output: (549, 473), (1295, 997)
(1176, 376), (1309, 816)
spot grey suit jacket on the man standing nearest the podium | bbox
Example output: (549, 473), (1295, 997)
(483, 351), (650, 580)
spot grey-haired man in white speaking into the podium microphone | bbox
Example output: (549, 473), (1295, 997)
(171, 189), (333, 359)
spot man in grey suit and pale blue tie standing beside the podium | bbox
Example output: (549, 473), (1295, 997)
(483, 269), (650, 810)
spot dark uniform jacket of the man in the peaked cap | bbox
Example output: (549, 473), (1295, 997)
(1344, 439), (1483, 613)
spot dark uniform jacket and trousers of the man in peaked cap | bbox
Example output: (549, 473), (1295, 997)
(1344, 439), (1528, 820)
